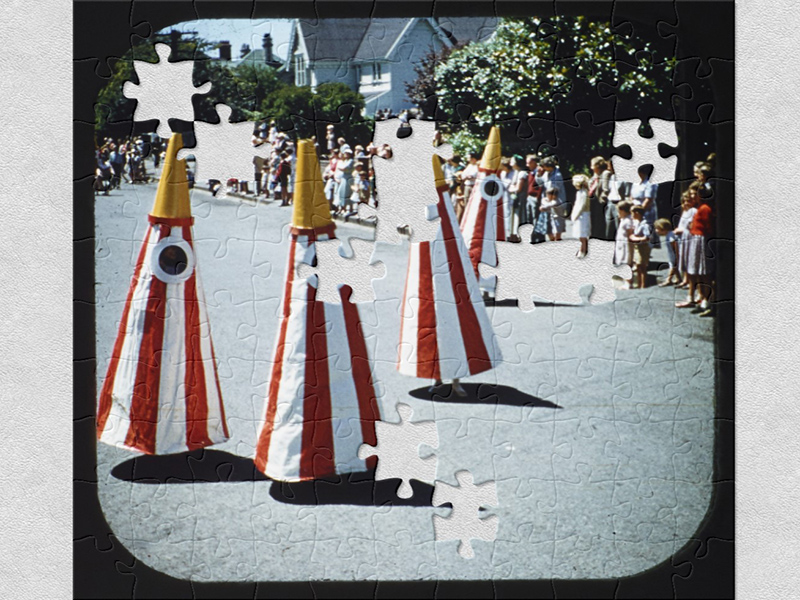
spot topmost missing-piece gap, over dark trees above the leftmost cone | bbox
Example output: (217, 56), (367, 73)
(122, 44), (211, 138)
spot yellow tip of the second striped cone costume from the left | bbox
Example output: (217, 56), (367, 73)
(292, 140), (333, 229)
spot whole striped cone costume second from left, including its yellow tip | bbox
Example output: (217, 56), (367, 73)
(255, 140), (380, 481)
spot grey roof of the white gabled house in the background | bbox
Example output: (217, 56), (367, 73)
(292, 17), (497, 61)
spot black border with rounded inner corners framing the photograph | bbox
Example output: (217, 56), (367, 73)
(73, 0), (734, 598)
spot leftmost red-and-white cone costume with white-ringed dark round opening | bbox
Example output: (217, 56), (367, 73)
(97, 133), (229, 454)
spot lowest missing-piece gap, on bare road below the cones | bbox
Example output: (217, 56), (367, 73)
(433, 471), (499, 558)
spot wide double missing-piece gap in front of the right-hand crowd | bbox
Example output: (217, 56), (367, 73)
(478, 232), (631, 312)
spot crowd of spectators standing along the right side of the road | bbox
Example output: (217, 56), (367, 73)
(444, 147), (714, 316)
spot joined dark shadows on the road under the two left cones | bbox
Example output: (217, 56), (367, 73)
(111, 450), (433, 506)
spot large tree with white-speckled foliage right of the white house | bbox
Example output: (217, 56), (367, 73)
(435, 17), (675, 155)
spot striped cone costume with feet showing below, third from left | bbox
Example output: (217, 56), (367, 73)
(397, 155), (502, 380)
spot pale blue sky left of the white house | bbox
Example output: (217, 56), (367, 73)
(159, 19), (292, 59)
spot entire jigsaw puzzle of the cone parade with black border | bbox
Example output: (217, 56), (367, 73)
(75, 2), (733, 597)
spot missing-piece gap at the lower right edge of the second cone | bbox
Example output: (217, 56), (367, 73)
(358, 404), (439, 498)
